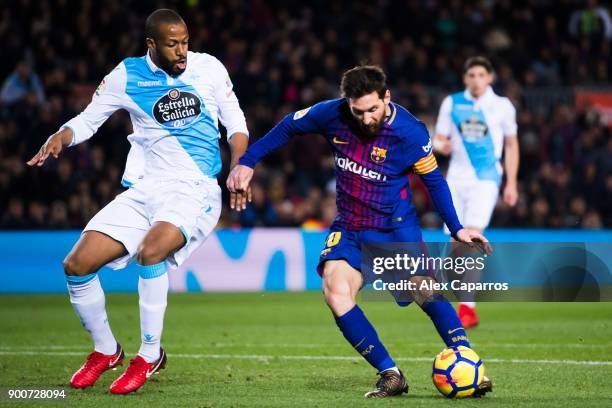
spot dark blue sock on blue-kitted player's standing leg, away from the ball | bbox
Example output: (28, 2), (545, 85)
(336, 305), (395, 372)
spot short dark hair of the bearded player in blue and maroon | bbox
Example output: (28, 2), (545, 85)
(340, 65), (387, 99)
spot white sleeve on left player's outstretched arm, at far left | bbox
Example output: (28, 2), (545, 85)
(60, 63), (127, 146)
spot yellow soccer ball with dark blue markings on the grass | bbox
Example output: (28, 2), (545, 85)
(432, 346), (485, 398)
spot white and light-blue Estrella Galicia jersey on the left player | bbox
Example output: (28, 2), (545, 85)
(62, 52), (248, 183)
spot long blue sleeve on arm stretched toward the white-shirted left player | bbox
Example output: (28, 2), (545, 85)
(239, 101), (331, 167)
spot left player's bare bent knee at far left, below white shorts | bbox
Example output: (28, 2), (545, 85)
(64, 231), (128, 276)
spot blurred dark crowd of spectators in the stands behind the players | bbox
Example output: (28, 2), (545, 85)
(0, 0), (612, 229)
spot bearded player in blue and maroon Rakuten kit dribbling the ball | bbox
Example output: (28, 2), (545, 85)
(227, 66), (491, 398)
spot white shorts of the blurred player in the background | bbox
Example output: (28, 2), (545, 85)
(444, 180), (499, 234)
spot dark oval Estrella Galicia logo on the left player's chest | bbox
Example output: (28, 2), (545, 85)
(153, 88), (202, 128)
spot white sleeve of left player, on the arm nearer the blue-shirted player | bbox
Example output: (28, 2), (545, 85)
(215, 56), (249, 140)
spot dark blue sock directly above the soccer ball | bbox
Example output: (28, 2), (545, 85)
(422, 295), (471, 348)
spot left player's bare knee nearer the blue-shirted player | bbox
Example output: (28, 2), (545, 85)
(137, 221), (185, 264)
